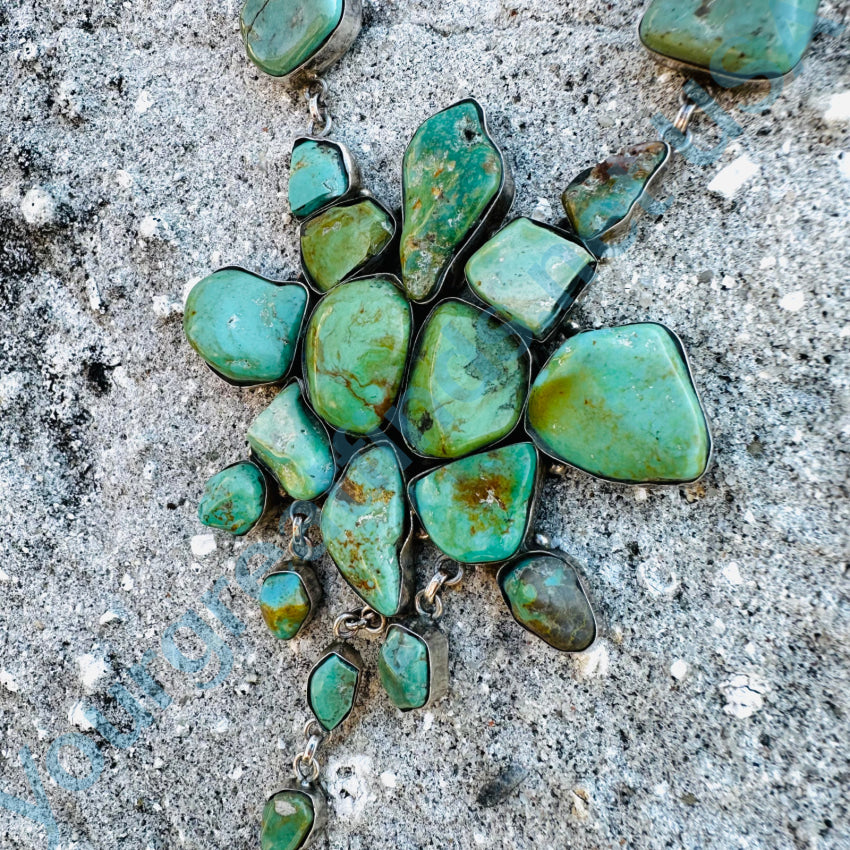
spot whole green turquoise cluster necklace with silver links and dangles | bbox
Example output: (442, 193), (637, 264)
(184, 0), (817, 850)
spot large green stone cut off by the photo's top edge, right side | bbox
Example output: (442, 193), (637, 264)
(640, 0), (818, 79)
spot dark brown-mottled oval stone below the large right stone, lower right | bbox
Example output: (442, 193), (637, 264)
(499, 553), (596, 652)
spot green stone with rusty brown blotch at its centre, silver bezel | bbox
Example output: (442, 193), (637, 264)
(411, 443), (537, 564)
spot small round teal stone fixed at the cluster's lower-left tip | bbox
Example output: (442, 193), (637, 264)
(198, 461), (266, 535)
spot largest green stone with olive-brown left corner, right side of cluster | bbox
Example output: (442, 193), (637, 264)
(527, 324), (711, 484)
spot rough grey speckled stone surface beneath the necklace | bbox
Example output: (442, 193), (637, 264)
(0, 0), (850, 850)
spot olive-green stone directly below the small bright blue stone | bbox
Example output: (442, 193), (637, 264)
(301, 198), (395, 292)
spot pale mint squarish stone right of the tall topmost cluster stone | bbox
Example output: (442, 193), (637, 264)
(466, 218), (596, 338)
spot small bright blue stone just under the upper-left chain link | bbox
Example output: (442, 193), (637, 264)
(289, 139), (351, 218)
